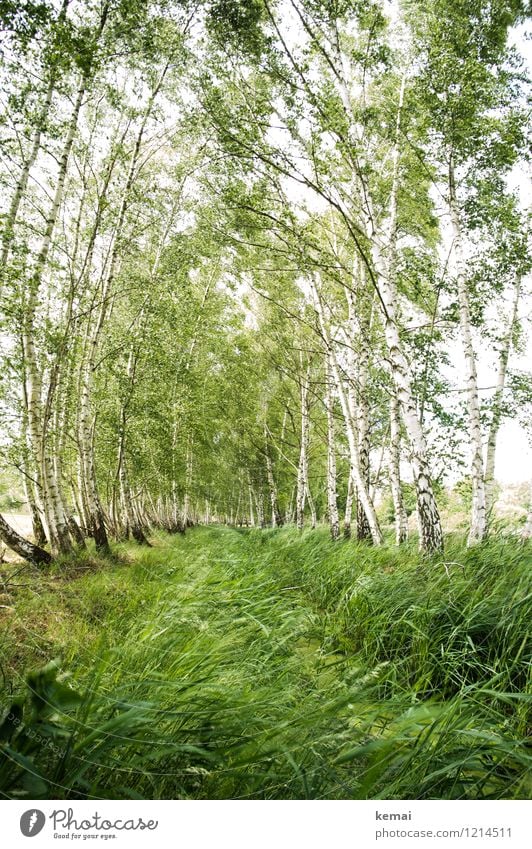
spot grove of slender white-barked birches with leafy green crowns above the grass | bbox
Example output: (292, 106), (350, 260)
(0, 0), (532, 566)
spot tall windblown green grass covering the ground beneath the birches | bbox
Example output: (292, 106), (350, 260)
(0, 527), (532, 799)
